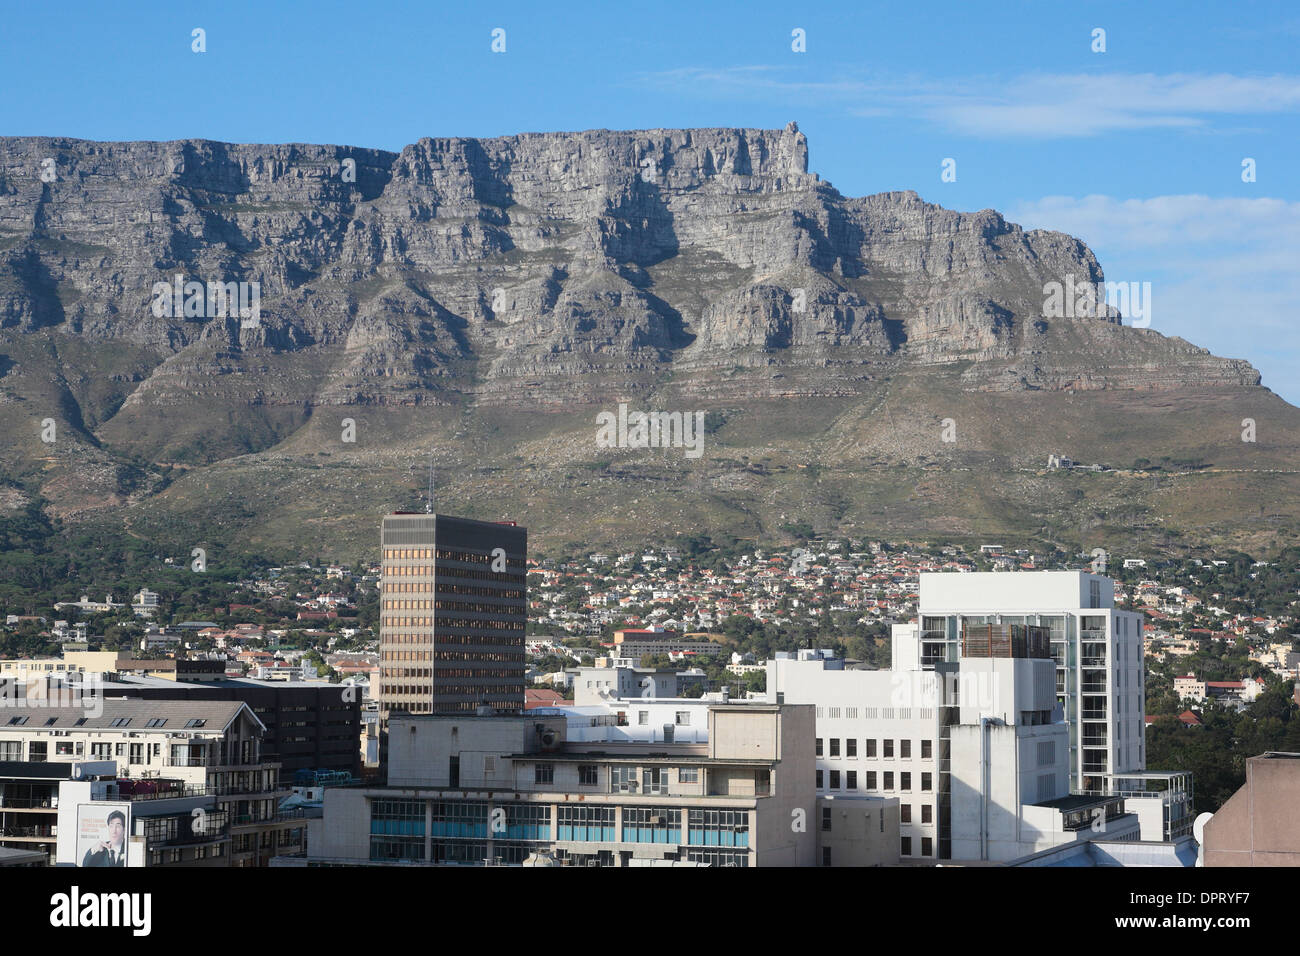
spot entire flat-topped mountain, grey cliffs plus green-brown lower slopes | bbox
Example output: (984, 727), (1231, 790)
(0, 124), (1300, 554)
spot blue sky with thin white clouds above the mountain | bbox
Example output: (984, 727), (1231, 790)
(0, 0), (1300, 403)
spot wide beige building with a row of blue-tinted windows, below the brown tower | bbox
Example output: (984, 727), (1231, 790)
(299, 704), (816, 866)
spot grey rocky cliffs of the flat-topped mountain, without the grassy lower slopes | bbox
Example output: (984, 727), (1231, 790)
(0, 124), (1257, 403)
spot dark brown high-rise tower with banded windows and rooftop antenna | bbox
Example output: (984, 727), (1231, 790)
(378, 512), (528, 727)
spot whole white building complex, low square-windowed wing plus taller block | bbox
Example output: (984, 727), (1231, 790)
(767, 572), (1154, 861)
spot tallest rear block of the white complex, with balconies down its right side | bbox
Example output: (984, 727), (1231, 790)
(918, 571), (1147, 791)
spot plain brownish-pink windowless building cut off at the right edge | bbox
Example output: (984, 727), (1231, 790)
(1201, 753), (1300, 866)
